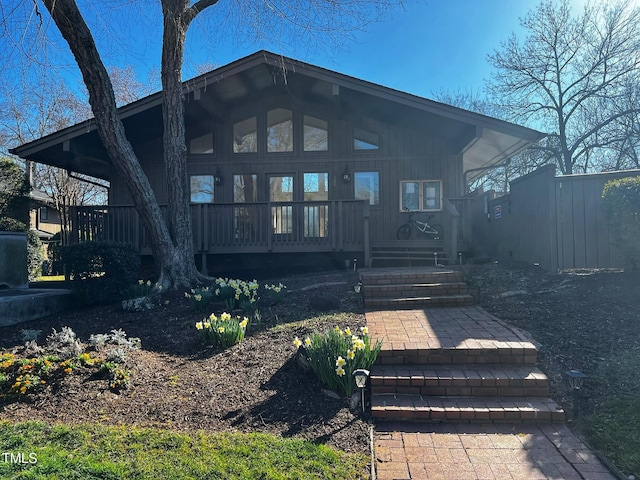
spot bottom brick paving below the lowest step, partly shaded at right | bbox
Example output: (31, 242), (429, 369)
(374, 422), (617, 480)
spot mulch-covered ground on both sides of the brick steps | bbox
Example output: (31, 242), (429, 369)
(0, 264), (640, 453)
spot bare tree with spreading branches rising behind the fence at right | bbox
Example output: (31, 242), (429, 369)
(489, 0), (640, 174)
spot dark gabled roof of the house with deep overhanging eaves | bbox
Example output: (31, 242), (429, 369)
(11, 51), (545, 180)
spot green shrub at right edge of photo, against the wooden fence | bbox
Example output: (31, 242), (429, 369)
(602, 177), (640, 270)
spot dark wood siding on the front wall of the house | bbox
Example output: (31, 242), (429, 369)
(109, 95), (463, 249)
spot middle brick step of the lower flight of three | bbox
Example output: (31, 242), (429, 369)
(370, 364), (549, 397)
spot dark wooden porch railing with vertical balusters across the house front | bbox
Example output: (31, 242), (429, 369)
(71, 200), (368, 253)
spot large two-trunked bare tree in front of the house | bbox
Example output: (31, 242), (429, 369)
(5, 0), (401, 287)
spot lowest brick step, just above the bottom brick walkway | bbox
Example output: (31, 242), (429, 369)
(371, 394), (565, 423)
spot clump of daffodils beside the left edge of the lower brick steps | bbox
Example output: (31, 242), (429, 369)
(293, 326), (382, 396)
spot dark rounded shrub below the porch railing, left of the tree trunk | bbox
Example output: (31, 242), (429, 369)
(60, 242), (140, 303)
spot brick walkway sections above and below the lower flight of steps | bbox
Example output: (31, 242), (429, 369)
(366, 307), (618, 480)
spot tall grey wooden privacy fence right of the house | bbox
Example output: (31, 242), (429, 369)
(470, 165), (640, 271)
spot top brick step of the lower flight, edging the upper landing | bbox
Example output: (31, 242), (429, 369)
(376, 339), (538, 365)
